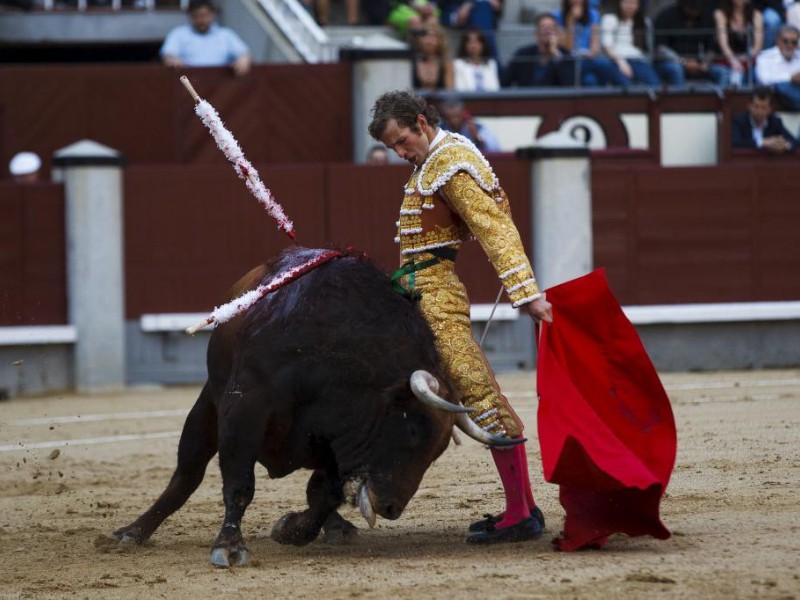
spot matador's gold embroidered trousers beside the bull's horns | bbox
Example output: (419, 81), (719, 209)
(403, 252), (523, 437)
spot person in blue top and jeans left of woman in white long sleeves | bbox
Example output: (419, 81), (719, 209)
(553, 0), (627, 86)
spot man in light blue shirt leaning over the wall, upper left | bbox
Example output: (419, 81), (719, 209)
(161, 0), (252, 76)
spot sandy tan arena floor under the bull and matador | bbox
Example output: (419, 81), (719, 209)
(0, 370), (800, 600)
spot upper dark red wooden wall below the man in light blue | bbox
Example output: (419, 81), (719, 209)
(0, 64), (353, 173)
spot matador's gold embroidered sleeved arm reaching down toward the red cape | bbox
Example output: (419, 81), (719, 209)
(439, 171), (542, 308)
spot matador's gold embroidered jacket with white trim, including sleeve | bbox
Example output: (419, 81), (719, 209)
(395, 133), (541, 308)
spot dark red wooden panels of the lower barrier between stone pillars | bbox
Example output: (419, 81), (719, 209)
(0, 155), (800, 325)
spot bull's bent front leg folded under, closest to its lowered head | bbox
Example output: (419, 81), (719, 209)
(270, 470), (346, 546)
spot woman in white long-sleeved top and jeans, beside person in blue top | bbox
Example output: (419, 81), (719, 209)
(600, 0), (664, 86)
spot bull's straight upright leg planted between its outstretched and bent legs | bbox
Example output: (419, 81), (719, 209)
(211, 389), (265, 567)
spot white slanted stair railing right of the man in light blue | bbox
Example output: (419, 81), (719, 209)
(253, 0), (339, 63)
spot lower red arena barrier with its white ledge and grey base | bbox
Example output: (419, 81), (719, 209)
(0, 153), (800, 395)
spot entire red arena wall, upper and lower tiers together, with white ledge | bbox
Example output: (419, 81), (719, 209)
(0, 64), (800, 394)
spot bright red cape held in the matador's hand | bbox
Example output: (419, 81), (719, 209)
(537, 270), (677, 551)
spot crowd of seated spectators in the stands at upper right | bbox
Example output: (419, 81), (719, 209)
(294, 0), (800, 110)
